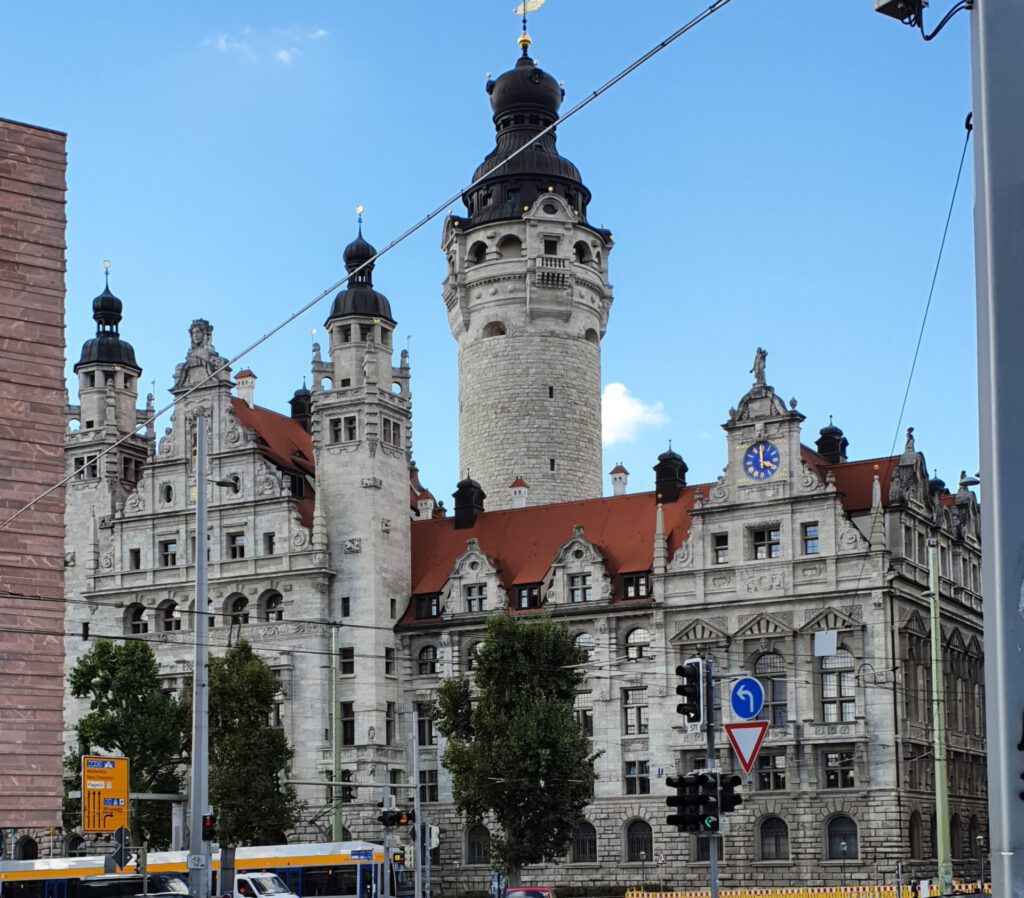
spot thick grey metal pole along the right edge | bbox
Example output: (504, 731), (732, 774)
(971, 0), (1024, 898)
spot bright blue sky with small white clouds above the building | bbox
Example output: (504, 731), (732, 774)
(0, 0), (978, 504)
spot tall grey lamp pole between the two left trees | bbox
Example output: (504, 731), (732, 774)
(188, 414), (210, 898)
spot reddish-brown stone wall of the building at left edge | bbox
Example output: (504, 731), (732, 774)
(0, 119), (67, 828)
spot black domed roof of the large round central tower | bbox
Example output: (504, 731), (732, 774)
(462, 34), (590, 226)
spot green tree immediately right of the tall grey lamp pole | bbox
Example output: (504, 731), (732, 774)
(187, 641), (302, 845)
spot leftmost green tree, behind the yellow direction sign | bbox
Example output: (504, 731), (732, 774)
(65, 640), (187, 849)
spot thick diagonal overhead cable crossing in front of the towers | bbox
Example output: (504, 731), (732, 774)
(0, 0), (730, 530)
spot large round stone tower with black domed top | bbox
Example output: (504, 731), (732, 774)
(442, 34), (611, 509)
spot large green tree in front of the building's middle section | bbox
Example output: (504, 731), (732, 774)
(434, 614), (596, 878)
